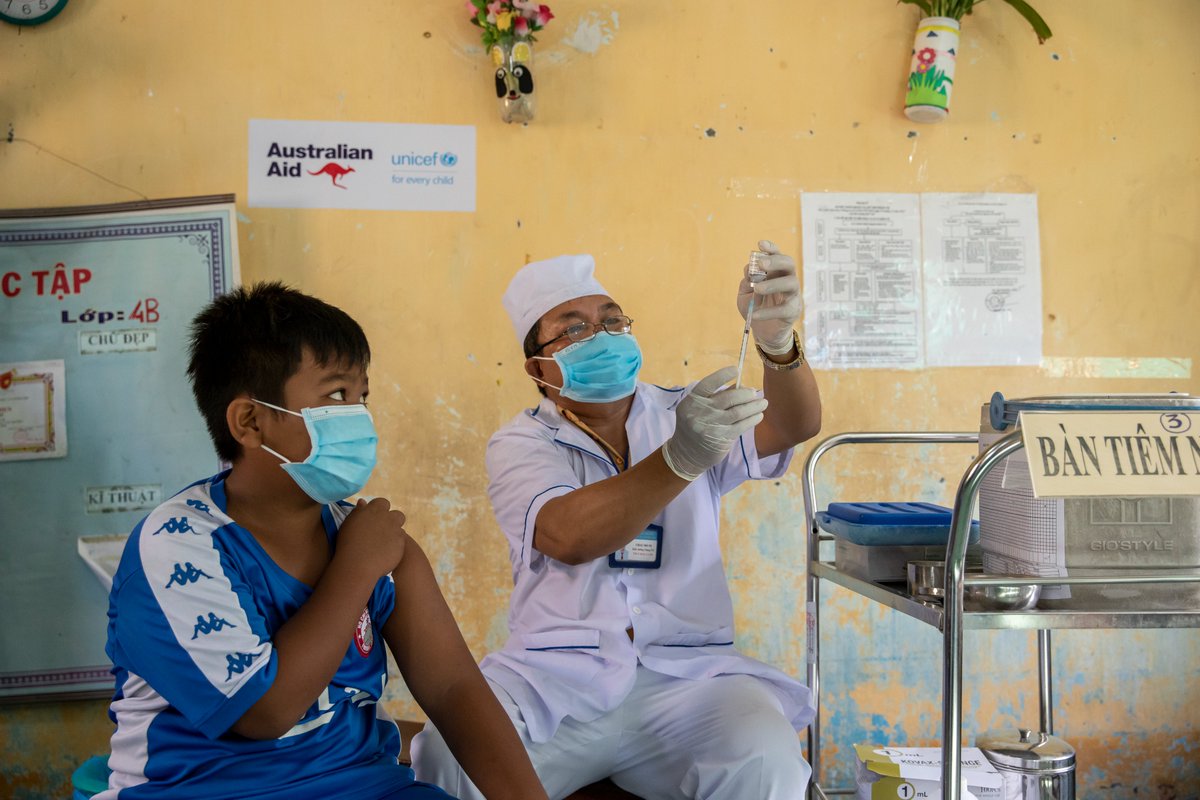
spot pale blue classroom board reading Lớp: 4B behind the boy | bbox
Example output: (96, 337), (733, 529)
(0, 196), (238, 700)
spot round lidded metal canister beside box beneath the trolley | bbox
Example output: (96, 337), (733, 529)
(976, 728), (1075, 800)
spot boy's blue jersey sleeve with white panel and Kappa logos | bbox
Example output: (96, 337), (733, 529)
(114, 512), (276, 739)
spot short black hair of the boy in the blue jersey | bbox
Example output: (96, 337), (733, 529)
(187, 282), (371, 462)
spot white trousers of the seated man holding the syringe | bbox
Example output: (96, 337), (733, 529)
(412, 666), (811, 800)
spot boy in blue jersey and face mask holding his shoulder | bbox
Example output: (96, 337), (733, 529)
(97, 283), (546, 800)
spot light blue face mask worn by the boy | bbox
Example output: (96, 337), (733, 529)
(254, 399), (379, 503)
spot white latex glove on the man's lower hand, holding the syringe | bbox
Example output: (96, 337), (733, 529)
(662, 367), (767, 481)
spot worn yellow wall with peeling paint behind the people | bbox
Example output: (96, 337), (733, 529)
(0, 0), (1200, 796)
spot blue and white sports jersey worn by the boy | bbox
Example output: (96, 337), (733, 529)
(96, 473), (413, 800)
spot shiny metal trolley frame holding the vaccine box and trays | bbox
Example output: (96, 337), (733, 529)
(803, 424), (1200, 800)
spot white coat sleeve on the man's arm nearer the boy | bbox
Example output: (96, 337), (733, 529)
(487, 426), (581, 572)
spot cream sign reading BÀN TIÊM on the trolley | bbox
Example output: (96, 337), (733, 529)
(1020, 411), (1200, 498)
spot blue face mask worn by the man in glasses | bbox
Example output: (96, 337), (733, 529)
(534, 333), (642, 403)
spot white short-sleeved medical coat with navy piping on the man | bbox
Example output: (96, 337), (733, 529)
(481, 383), (814, 742)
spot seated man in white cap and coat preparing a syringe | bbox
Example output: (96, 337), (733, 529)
(413, 241), (821, 800)
